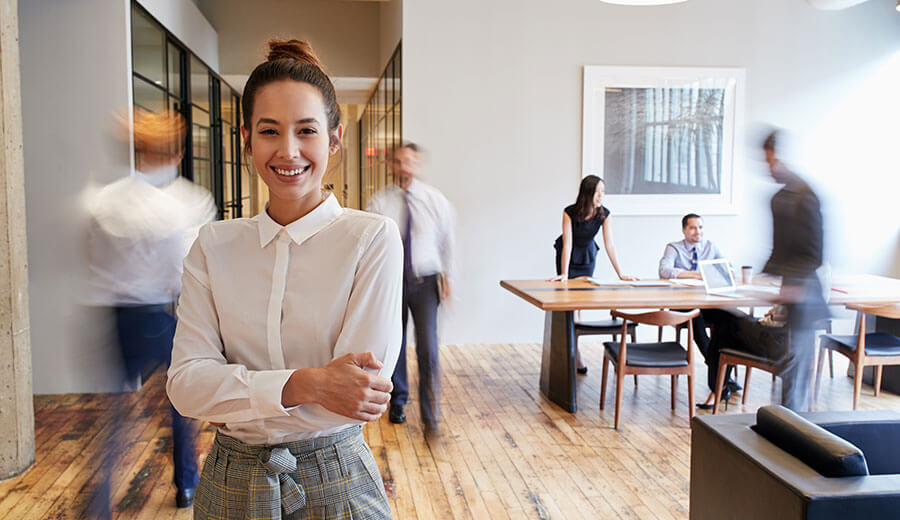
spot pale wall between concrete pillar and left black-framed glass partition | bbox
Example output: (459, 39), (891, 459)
(19, 0), (216, 394)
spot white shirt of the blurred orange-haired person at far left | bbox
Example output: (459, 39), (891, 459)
(84, 167), (216, 306)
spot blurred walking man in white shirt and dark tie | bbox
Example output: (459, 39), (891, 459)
(367, 143), (454, 434)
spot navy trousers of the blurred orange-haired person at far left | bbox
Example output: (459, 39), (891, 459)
(116, 305), (199, 489)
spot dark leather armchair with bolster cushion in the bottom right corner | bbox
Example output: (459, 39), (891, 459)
(690, 406), (900, 520)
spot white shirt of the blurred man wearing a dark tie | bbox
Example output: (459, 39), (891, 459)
(366, 179), (455, 280)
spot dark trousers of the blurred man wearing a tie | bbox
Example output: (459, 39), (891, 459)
(391, 275), (441, 426)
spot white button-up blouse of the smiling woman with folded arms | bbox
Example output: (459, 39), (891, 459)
(166, 196), (403, 444)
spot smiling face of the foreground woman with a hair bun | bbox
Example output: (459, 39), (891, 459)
(241, 80), (342, 204)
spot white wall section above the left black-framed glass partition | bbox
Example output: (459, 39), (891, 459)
(138, 0), (219, 73)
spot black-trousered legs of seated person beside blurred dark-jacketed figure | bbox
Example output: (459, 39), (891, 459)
(697, 305), (787, 410)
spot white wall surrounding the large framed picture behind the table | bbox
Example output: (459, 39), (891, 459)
(403, 0), (900, 343)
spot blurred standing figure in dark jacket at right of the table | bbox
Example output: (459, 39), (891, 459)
(762, 131), (829, 411)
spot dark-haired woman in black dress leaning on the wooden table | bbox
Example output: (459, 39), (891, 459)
(551, 175), (637, 374)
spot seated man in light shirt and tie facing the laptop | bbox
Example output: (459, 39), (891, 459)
(659, 213), (741, 392)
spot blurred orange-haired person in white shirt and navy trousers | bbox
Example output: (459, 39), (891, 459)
(87, 110), (215, 517)
